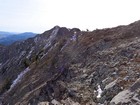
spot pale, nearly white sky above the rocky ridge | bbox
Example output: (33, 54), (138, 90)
(0, 0), (140, 32)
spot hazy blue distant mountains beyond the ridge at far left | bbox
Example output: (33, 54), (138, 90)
(0, 31), (36, 46)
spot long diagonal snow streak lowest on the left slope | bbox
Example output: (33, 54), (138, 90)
(9, 67), (30, 90)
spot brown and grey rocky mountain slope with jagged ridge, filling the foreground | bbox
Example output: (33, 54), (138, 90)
(0, 21), (140, 105)
